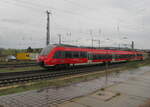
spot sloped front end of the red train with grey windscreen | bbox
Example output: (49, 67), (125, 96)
(37, 45), (54, 67)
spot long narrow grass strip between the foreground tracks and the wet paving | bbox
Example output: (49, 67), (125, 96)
(0, 59), (150, 96)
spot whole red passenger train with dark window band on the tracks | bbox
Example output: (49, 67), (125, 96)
(37, 44), (144, 67)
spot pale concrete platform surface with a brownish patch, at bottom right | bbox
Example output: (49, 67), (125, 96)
(57, 67), (150, 107)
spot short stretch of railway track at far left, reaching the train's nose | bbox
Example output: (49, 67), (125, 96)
(0, 63), (38, 68)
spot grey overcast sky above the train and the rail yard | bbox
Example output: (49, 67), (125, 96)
(0, 0), (150, 49)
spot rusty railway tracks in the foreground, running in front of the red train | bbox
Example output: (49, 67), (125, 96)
(0, 63), (129, 87)
